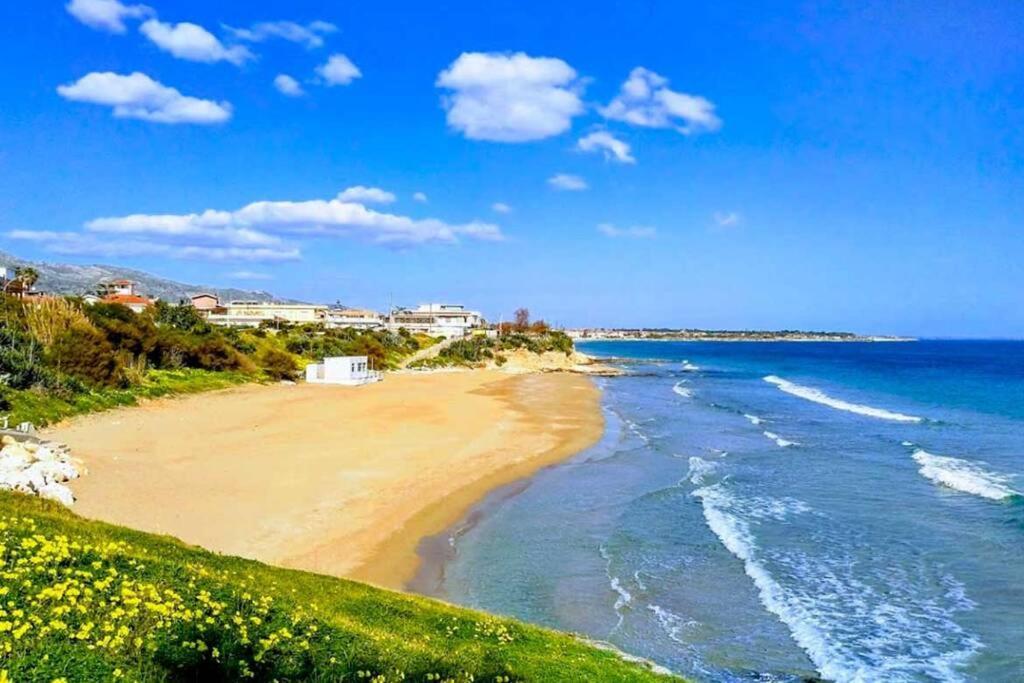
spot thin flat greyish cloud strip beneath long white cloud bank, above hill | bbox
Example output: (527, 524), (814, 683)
(4, 230), (301, 261)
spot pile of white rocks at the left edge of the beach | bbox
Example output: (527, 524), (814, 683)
(0, 434), (80, 506)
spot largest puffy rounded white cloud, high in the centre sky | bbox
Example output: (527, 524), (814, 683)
(435, 52), (584, 142)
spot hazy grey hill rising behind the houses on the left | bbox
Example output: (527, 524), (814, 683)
(0, 252), (286, 303)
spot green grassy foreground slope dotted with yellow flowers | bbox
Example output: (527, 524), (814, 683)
(0, 493), (671, 682)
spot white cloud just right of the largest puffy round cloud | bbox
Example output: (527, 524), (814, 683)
(600, 67), (722, 135)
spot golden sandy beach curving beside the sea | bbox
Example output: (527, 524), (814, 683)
(46, 371), (603, 588)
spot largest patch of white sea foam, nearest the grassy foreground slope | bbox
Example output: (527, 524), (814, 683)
(692, 483), (982, 683)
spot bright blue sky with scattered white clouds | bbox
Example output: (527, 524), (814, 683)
(0, 0), (1024, 337)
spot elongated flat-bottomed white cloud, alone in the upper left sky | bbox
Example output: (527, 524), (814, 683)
(57, 72), (231, 125)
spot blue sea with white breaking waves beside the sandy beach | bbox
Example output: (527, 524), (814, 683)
(438, 341), (1024, 681)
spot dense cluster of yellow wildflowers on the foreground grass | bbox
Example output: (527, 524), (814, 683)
(0, 517), (317, 683)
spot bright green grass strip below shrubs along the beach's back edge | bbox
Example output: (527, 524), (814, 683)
(2, 369), (259, 427)
